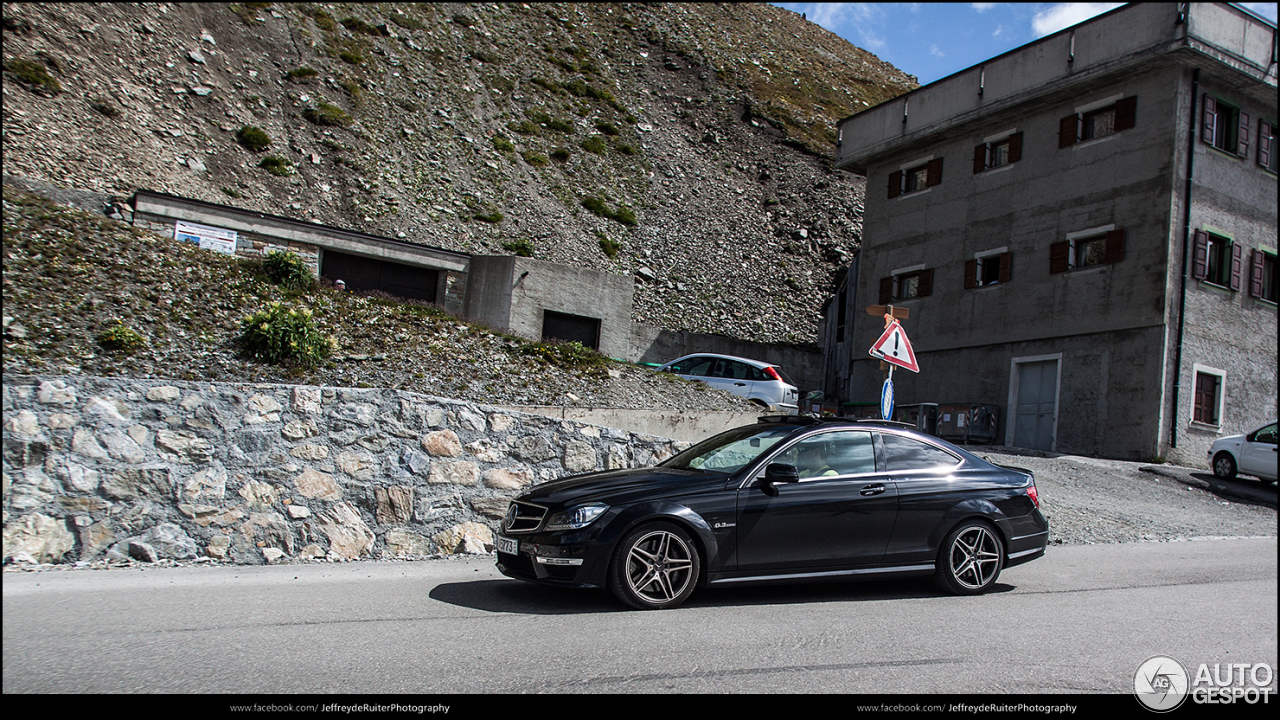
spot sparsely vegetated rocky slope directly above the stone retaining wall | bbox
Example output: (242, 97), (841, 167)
(4, 183), (754, 410)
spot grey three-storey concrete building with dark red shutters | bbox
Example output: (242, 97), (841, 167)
(824, 3), (1277, 466)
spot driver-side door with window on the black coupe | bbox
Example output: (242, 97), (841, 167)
(736, 429), (897, 573)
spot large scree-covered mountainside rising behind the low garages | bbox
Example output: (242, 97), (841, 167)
(3, 3), (915, 343)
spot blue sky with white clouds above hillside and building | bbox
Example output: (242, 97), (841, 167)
(774, 3), (1276, 85)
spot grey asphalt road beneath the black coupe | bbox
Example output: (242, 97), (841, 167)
(3, 538), (1277, 701)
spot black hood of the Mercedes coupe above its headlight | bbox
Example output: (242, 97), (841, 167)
(520, 468), (728, 509)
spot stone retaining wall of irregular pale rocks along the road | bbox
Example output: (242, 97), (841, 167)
(3, 377), (687, 564)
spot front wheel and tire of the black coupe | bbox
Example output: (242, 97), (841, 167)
(609, 523), (703, 610)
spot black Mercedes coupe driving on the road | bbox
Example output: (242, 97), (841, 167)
(497, 416), (1048, 610)
